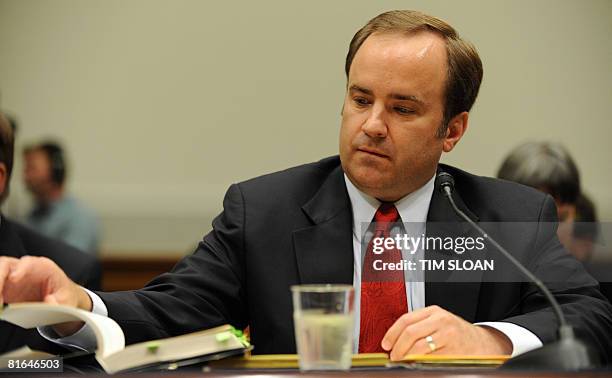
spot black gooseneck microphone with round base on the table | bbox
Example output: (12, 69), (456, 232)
(437, 172), (598, 371)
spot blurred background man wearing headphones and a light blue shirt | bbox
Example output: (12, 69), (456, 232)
(23, 141), (98, 254)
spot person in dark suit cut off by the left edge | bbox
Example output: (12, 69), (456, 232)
(0, 113), (101, 353)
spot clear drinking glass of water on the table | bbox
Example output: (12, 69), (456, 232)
(291, 285), (355, 370)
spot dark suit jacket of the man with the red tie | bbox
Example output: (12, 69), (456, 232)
(99, 157), (612, 359)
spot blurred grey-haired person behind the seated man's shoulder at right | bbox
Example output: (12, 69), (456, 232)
(497, 142), (581, 254)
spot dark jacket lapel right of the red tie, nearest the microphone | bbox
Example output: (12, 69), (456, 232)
(425, 168), (482, 322)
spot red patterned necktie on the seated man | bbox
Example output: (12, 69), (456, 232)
(359, 203), (408, 353)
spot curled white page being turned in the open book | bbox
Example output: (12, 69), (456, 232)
(0, 302), (125, 358)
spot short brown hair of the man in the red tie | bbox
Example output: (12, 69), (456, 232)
(344, 10), (482, 137)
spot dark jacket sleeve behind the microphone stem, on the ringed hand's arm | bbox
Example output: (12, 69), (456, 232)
(503, 196), (612, 362)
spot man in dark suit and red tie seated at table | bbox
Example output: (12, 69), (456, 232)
(0, 11), (612, 359)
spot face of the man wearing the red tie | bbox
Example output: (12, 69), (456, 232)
(340, 32), (467, 201)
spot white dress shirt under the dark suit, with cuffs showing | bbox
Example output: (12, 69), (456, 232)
(43, 175), (542, 356)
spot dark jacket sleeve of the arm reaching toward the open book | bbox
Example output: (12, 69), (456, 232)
(97, 185), (248, 344)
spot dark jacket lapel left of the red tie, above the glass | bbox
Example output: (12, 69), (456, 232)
(292, 166), (353, 284)
